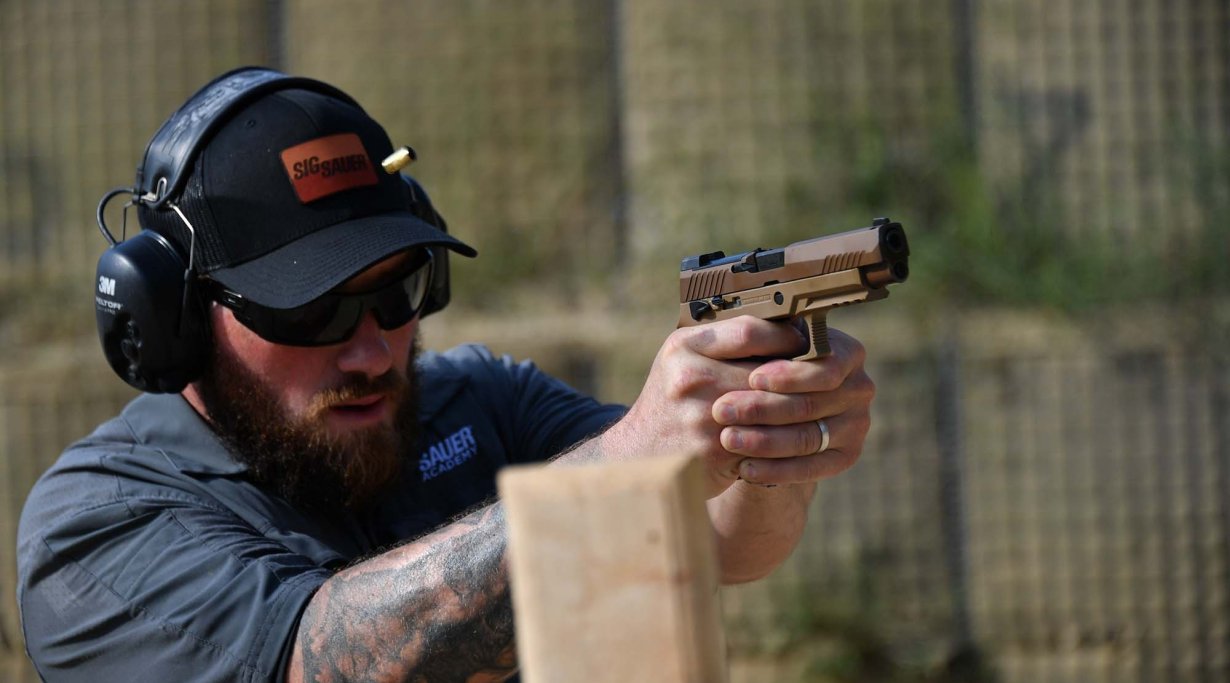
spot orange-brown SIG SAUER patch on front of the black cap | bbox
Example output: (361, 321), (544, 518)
(282, 133), (380, 204)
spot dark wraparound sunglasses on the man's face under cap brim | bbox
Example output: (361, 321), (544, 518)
(213, 250), (432, 346)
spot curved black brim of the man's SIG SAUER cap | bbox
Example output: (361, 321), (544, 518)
(209, 212), (478, 309)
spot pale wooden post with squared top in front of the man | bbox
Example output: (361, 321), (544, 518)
(499, 457), (727, 683)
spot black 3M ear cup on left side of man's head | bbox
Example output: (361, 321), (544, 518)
(93, 230), (209, 394)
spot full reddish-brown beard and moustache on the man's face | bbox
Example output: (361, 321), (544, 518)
(197, 337), (421, 511)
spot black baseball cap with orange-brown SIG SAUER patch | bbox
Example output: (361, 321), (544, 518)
(139, 76), (477, 309)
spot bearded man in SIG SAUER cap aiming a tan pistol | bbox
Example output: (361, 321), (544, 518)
(18, 69), (873, 682)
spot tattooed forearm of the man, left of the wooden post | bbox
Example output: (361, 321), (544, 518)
(288, 503), (517, 683)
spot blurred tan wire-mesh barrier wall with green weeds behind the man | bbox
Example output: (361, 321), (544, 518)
(0, 0), (1230, 683)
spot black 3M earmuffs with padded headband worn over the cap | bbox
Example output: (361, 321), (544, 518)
(95, 66), (449, 394)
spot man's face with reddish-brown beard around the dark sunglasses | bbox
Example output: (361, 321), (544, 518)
(185, 256), (418, 509)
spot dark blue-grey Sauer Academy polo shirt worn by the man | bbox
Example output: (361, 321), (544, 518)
(10, 346), (624, 683)
